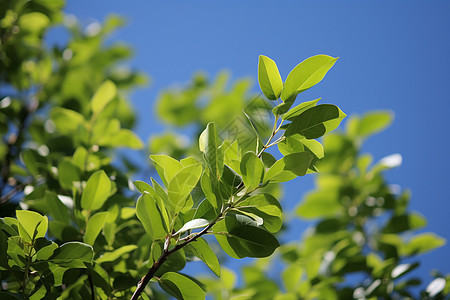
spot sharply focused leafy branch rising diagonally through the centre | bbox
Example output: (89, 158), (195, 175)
(129, 55), (345, 299)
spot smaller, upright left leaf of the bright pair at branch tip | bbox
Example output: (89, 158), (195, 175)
(258, 55), (283, 100)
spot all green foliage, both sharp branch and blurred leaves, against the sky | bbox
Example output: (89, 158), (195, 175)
(0, 0), (448, 299)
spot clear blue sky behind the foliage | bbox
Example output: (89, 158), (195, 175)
(66, 0), (450, 281)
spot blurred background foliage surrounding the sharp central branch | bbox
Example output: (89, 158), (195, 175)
(0, 0), (450, 299)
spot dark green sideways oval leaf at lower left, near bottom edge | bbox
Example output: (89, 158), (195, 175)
(49, 242), (94, 268)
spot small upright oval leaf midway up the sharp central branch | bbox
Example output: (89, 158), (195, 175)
(240, 152), (264, 190)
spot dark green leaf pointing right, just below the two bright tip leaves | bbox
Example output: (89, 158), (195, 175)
(285, 104), (346, 139)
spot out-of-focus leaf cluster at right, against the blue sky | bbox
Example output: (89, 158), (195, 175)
(204, 111), (450, 300)
